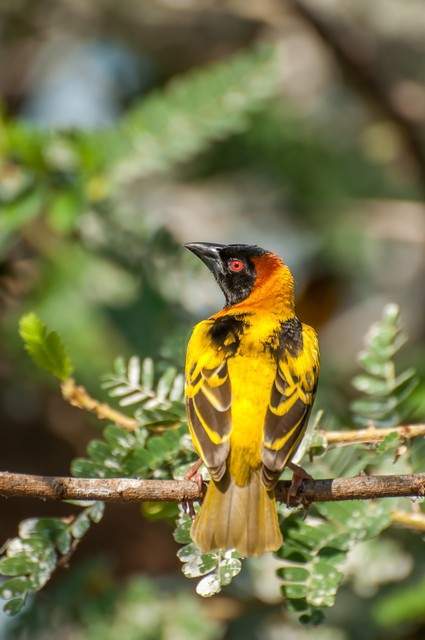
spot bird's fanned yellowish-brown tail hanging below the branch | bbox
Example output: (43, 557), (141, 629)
(191, 470), (283, 556)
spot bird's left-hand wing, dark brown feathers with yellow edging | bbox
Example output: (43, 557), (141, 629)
(186, 321), (231, 480)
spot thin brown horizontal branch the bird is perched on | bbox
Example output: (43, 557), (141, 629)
(0, 471), (425, 502)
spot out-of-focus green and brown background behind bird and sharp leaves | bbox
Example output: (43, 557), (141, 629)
(0, 0), (425, 640)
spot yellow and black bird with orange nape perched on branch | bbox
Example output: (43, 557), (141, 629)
(185, 242), (319, 557)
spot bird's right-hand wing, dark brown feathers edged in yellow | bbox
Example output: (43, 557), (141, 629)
(262, 325), (319, 487)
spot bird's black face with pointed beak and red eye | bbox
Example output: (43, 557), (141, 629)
(185, 242), (268, 306)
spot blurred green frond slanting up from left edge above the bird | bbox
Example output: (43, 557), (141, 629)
(0, 46), (279, 249)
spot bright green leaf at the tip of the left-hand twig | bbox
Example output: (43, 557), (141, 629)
(19, 313), (73, 380)
